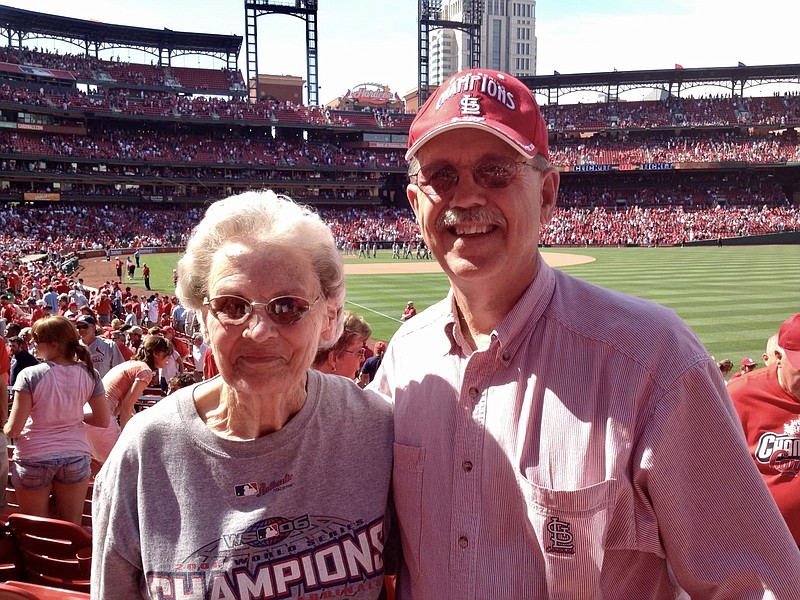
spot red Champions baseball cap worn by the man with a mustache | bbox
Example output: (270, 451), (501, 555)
(406, 69), (550, 160)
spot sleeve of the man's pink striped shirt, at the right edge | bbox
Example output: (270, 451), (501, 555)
(633, 360), (800, 600)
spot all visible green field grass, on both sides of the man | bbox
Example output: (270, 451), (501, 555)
(137, 246), (800, 365)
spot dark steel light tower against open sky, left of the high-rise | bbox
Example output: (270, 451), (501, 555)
(244, 0), (319, 106)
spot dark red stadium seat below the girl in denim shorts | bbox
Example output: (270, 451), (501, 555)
(7, 513), (92, 594)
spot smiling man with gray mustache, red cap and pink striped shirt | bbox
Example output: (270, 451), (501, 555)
(373, 69), (800, 600)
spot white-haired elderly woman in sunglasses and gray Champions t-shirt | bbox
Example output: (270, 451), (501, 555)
(92, 192), (392, 599)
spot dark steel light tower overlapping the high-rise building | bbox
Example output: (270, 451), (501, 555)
(417, 0), (483, 106)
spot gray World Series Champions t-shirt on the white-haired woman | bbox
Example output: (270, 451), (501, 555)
(92, 371), (393, 600)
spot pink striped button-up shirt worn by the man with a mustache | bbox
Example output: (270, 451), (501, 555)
(374, 260), (800, 600)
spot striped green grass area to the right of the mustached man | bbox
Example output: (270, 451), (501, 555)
(564, 246), (800, 364)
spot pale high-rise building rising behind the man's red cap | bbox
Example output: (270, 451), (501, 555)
(429, 0), (536, 85)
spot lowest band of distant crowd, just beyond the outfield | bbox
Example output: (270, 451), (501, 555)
(0, 205), (800, 265)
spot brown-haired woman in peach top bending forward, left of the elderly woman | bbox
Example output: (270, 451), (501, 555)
(86, 335), (172, 470)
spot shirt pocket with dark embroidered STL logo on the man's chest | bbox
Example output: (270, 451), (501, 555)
(520, 477), (619, 600)
